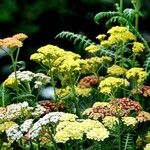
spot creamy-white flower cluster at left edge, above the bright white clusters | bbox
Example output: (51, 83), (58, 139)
(0, 101), (33, 120)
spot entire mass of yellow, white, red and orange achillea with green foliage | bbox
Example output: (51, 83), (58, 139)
(0, 0), (150, 150)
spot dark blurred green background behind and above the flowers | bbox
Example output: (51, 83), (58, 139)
(0, 0), (150, 82)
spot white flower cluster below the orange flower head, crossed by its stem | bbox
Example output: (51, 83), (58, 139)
(9, 71), (51, 88)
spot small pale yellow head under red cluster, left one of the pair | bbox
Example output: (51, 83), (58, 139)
(102, 116), (119, 129)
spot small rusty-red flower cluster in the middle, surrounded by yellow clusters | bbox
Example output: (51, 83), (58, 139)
(78, 75), (99, 88)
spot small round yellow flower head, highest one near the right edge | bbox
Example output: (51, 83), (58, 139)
(132, 42), (145, 54)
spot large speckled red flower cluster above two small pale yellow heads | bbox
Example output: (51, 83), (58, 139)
(88, 98), (142, 119)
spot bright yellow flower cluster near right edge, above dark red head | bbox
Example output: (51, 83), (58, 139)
(126, 67), (148, 84)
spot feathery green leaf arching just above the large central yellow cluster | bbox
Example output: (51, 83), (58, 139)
(55, 31), (94, 50)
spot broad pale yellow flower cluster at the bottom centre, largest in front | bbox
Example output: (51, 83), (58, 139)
(54, 119), (109, 143)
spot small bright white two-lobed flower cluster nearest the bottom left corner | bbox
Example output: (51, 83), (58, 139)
(6, 119), (33, 141)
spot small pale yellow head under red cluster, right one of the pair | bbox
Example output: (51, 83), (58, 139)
(122, 117), (137, 127)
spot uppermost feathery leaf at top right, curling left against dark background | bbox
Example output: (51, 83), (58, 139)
(94, 11), (119, 23)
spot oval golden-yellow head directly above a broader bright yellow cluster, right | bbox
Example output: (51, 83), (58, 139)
(107, 65), (127, 76)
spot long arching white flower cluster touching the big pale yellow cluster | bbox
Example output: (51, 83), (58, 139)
(28, 112), (64, 139)
